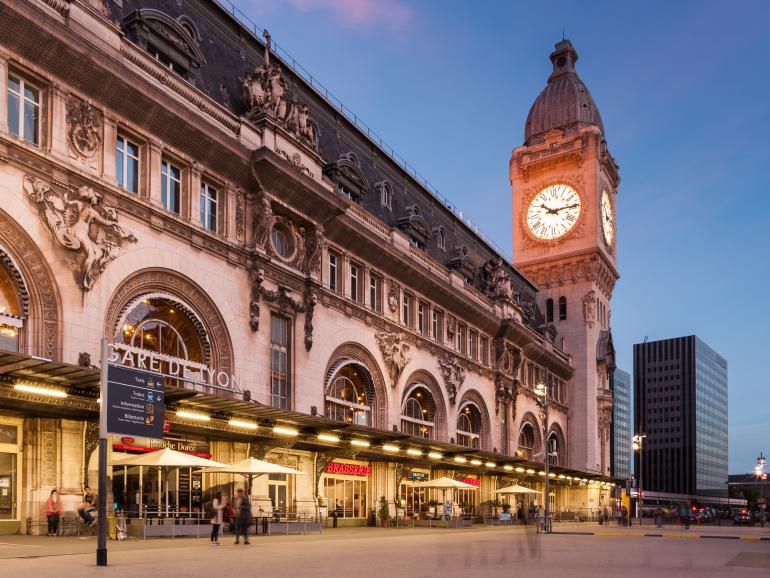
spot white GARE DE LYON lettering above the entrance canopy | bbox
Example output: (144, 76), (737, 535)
(108, 343), (241, 392)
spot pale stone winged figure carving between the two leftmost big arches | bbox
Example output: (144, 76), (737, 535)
(24, 175), (136, 291)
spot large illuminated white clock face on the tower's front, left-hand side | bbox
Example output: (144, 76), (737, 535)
(527, 183), (580, 240)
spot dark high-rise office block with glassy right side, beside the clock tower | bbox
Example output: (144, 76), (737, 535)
(634, 335), (727, 495)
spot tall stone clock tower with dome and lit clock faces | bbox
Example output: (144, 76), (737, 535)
(510, 40), (620, 475)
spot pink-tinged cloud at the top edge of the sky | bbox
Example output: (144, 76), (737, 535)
(282, 0), (414, 28)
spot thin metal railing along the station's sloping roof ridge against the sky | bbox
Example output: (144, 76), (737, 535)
(214, 0), (511, 261)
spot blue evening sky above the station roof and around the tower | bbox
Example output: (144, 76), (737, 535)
(235, 0), (770, 473)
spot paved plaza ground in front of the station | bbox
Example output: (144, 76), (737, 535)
(0, 525), (770, 578)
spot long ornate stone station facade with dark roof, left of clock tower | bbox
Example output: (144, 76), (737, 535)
(0, 0), (614, 533)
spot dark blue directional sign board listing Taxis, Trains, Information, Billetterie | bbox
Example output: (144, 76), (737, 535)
(106, 365), (165, 439)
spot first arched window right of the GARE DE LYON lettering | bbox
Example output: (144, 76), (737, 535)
(326, 364), (374, 426)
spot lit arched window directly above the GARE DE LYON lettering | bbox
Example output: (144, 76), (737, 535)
(115, 296), (208, 368)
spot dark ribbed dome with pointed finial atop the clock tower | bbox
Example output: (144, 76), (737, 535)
(524, 40), (604, 146)
